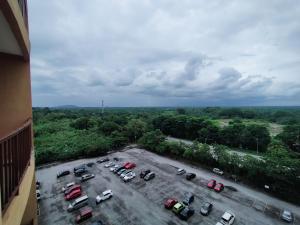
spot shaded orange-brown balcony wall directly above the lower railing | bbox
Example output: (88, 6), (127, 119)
(0, 56), (32, 139)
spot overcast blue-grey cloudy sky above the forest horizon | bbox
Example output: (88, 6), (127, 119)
(28, 0), (300, 107)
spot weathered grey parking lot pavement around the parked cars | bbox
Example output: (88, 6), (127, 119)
(36, 148), (300, 225)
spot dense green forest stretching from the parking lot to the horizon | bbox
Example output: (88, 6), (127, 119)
(33, 107), (300, 202)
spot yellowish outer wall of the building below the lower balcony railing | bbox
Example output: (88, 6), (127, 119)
(2, 155), (37, 225)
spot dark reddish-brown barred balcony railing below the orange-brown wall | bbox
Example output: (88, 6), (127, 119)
(0, 121), (32, 212)
